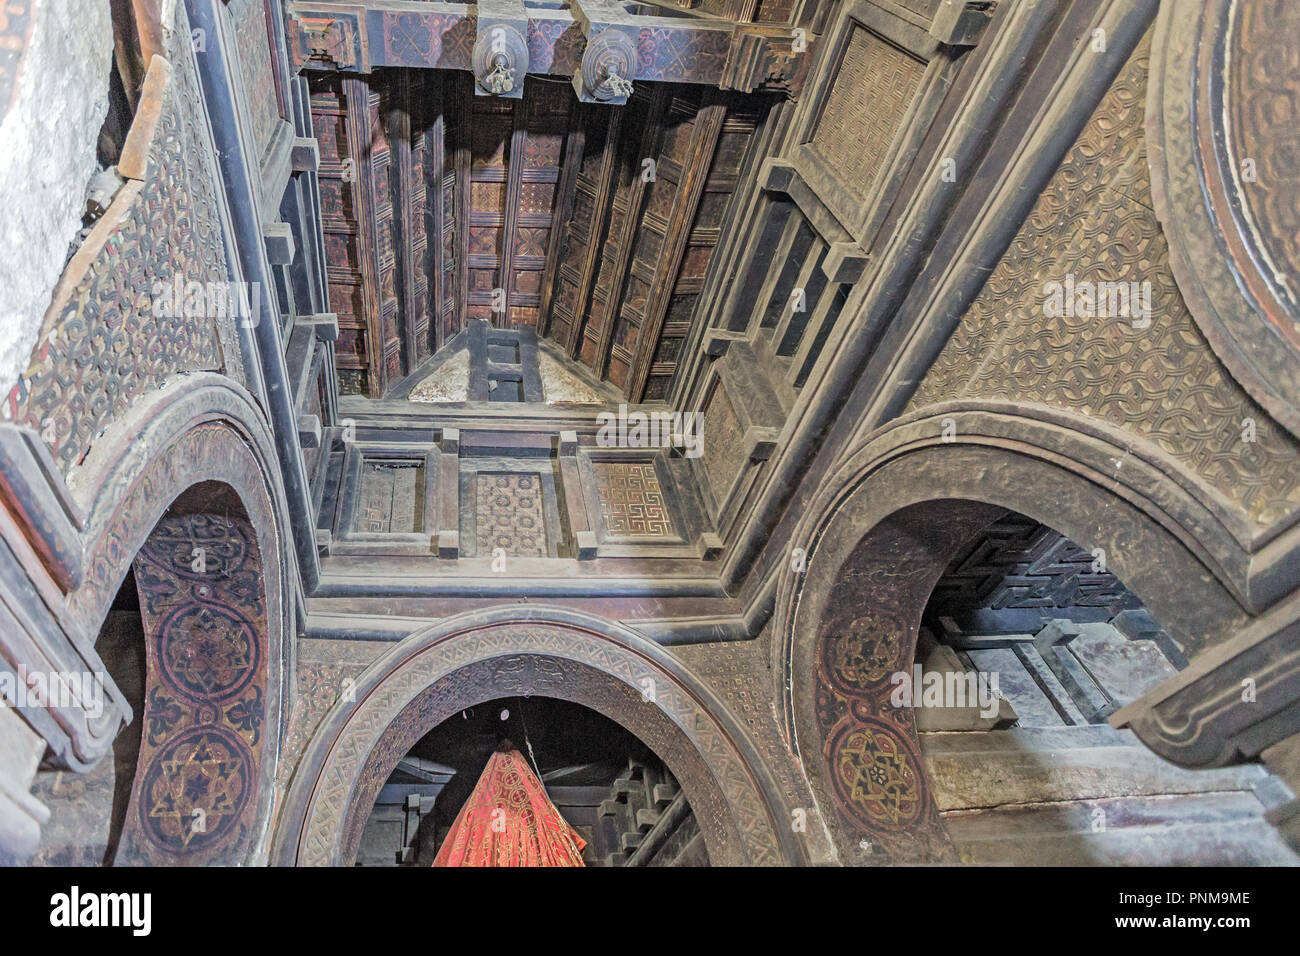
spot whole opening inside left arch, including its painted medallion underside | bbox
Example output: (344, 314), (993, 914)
(31, 481), (274, 866)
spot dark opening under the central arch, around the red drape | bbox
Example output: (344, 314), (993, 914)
(356, 697), (709, 866)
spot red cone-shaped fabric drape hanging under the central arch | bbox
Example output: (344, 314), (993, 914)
(433, 745), (586, 866)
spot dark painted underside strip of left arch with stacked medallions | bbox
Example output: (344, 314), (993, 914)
(116, 489), (269, 865)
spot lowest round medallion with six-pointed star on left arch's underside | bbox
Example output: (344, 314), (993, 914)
(139, 727), (254, 853)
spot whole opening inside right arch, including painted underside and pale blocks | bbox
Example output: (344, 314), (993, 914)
(793, 486), (1294, 865)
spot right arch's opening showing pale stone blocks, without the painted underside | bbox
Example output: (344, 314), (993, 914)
(915, 512), (1296, 865)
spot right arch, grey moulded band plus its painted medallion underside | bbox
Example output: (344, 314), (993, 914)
(774, 407), (1248, 862)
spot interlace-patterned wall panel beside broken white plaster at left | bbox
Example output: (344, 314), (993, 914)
(4, 12), (229, 475)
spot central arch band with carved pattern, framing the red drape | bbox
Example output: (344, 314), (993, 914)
(276, 606), (802, 865)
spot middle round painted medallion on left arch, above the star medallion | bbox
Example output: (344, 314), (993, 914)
(159, 604), (261, 701)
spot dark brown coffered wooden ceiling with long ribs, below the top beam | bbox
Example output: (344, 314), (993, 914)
(311, 69), (768, 401)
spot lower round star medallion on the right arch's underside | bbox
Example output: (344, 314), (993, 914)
(828, 721), (928, 830)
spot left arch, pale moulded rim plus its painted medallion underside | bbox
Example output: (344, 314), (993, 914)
(57, 375), (296, 865)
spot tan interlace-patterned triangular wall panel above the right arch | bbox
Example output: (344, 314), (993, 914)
(910, 36), (1300, 529)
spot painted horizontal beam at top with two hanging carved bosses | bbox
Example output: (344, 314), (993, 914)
(287, 0), (811, 98)
